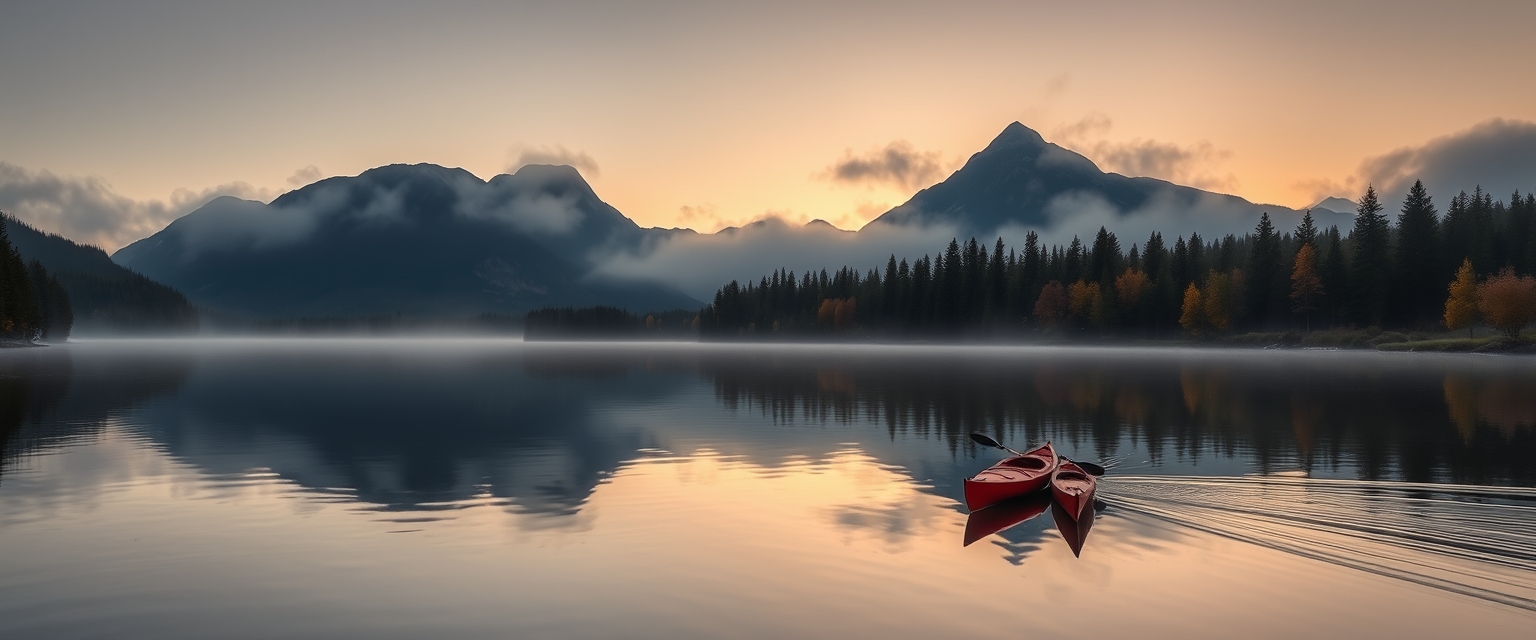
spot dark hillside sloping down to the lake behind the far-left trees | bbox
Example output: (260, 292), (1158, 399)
(5, 216), (198, 335)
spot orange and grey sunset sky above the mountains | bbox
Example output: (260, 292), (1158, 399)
(0, 0), (1536, 250)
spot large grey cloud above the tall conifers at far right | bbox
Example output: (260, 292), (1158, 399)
(1357, 118), (1536, 202)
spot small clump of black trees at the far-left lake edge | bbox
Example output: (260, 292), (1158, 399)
(0, 218), (75, 341)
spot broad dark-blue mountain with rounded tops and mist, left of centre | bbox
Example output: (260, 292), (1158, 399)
(112, 164), (700, 318)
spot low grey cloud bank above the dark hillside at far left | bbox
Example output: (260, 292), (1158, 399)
(0, 163), (276, 252)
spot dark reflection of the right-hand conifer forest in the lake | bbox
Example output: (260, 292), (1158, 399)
(708, 350), (1536, 485)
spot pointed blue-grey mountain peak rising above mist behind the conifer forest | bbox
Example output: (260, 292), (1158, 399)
(866, 123), (1289, 238)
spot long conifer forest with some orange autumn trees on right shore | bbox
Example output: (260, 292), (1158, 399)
(700, 183), (1536, 336)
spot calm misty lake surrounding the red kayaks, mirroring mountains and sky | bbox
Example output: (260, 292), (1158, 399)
(0, 339), (1536, 640)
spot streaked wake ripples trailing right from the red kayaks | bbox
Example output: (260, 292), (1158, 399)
(1103, 476), (1536, 612)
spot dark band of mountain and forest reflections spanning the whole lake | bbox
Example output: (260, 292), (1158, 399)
(0, 341), (1536, 516)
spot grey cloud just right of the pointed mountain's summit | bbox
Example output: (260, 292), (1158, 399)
(1052, 114), (1238, 193)
